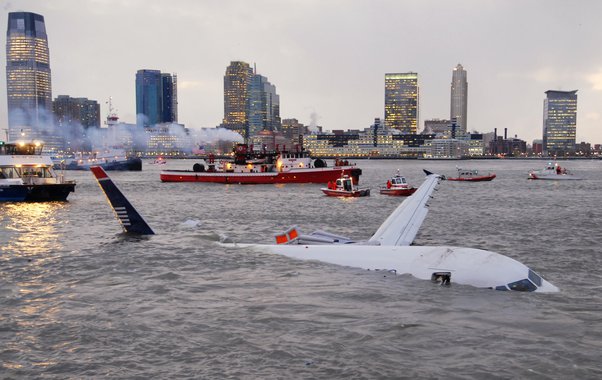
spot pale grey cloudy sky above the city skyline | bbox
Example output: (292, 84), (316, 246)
(0, 0), (602, 143)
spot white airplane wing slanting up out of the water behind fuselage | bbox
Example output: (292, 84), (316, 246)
(368, 173), (441, 245)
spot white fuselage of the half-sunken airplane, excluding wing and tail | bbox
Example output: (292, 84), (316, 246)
(227, 244), (558, 292)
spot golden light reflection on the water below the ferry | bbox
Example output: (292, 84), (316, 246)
(0, 202), (68, 369)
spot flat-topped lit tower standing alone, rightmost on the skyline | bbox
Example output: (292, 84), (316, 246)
(543, 90), (577, 155)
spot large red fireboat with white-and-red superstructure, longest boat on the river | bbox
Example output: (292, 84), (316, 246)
(161, 144), (362, 184)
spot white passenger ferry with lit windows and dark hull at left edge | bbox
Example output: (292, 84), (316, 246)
(0, 142), (75, 202)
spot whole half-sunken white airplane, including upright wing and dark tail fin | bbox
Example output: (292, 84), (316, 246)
(93, 168), (559, 293)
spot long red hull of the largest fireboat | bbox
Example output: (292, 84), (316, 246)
(161, 166), (362, 184)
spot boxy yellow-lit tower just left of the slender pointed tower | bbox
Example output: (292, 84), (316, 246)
(385, 73), (418, 134)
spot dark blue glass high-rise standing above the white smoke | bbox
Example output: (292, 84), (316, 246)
(136, 70), (178, 126)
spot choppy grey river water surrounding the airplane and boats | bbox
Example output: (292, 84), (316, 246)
(0, 160), (602, 379)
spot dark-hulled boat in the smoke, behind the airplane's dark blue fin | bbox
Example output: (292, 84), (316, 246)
(53, 149), (142, 171)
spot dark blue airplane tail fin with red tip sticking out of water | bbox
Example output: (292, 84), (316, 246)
(90, 166), (155, 235)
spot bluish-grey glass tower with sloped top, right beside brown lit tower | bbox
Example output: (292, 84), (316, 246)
(249, 74), (281, 137)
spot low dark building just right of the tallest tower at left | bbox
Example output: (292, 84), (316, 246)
(52, 95), (100, 129)
